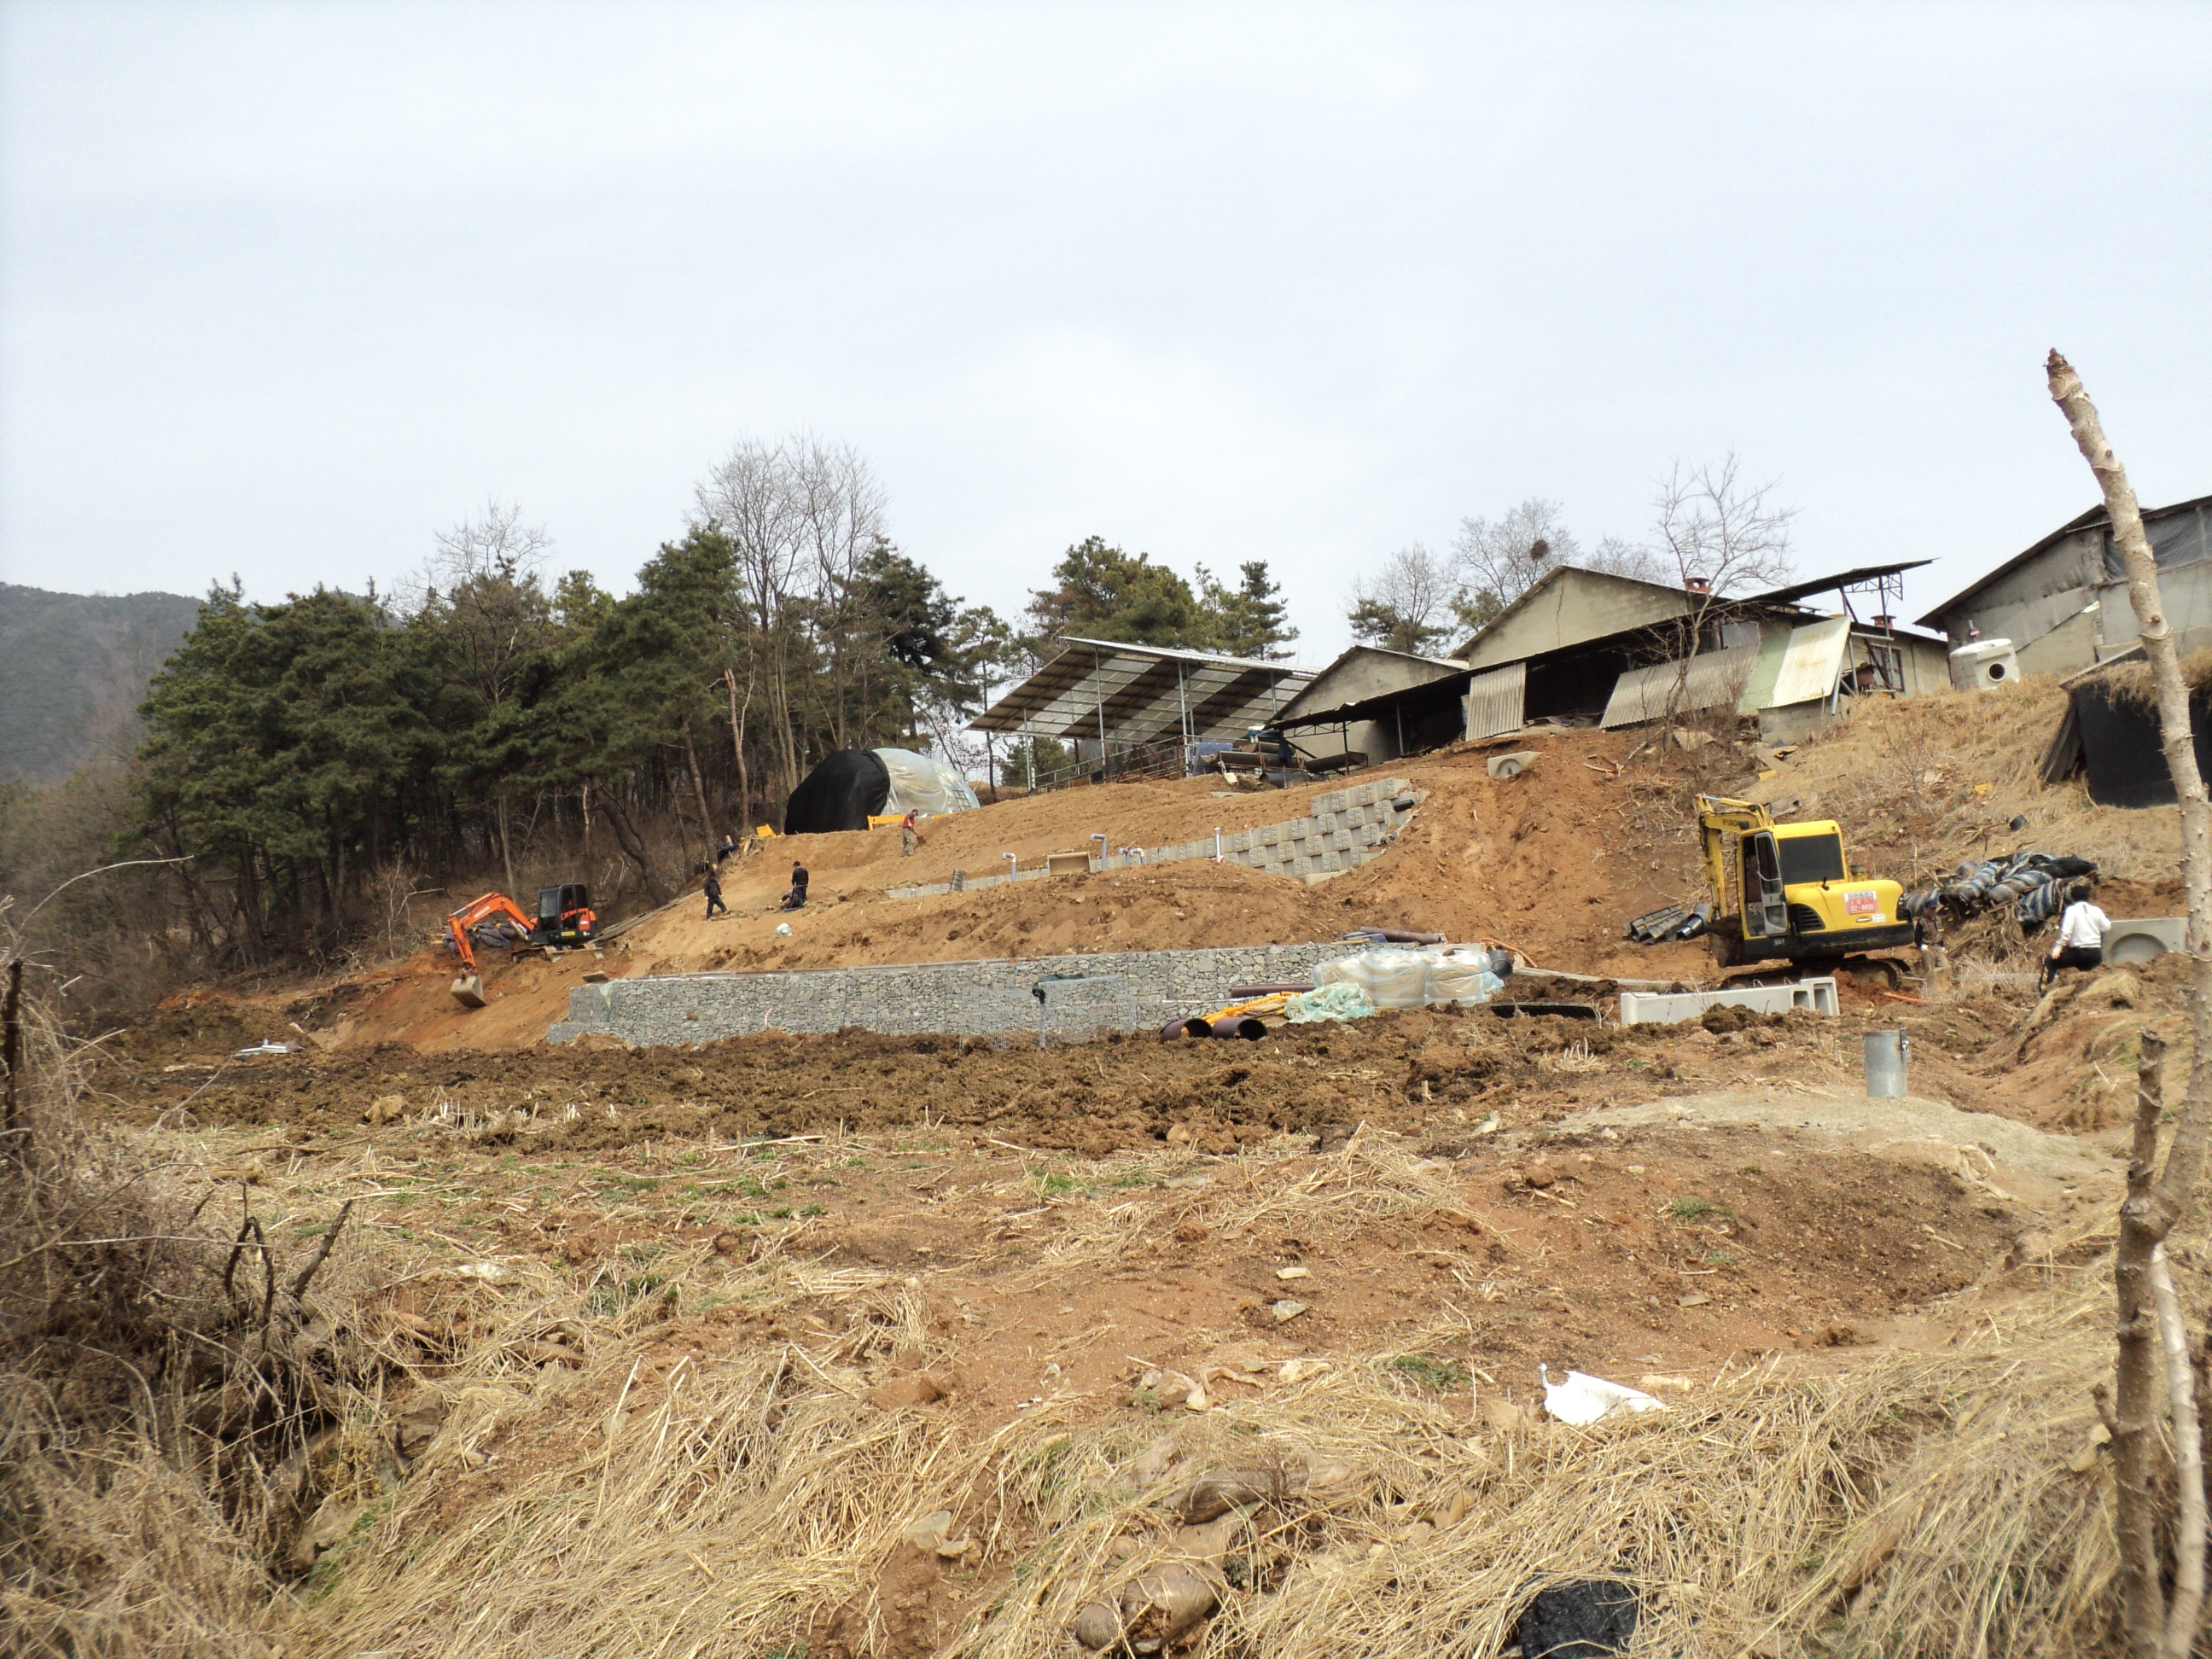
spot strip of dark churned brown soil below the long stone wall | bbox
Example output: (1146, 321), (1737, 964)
(97, 958), (2190, 1185)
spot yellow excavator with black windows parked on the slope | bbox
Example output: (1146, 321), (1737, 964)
(1697, 795), (1913, 982)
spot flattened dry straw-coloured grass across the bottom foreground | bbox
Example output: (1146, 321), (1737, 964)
(296, 1270), (2141, 1659)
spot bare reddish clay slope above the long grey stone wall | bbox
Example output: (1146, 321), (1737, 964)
(147, 716), (2174, 1053)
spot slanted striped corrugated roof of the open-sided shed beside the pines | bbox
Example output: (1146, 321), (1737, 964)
(969, 637), (1314, 743)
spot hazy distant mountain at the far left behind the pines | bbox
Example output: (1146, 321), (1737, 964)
(0, 582), (199, 783)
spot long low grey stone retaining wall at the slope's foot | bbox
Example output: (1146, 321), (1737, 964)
(546, 940), (1365, 1049)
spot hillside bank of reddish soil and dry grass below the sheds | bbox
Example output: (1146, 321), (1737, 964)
(143, 684), (2179, 1051)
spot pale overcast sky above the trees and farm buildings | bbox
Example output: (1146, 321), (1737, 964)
(0, 0), (2212, 659)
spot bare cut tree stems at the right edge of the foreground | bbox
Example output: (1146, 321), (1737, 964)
(2044, 352), (2212, 1659)
